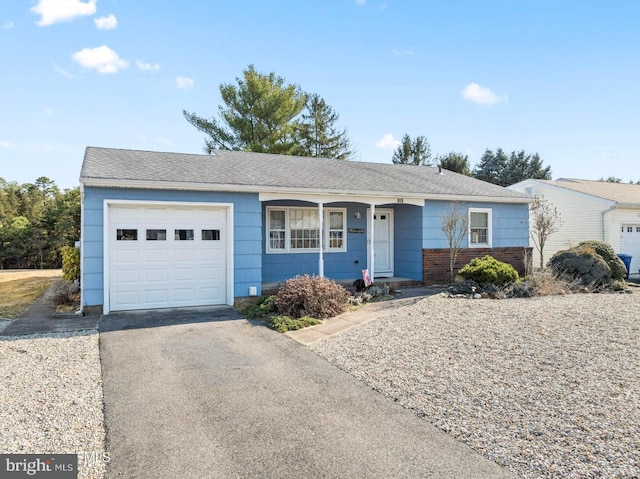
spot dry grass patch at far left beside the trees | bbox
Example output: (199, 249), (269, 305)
(0, 269), (62, 319)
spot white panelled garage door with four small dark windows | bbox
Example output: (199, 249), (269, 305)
(108, 205), (228, 311)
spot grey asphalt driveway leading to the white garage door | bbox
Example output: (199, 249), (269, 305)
(100, 308), (512, 478)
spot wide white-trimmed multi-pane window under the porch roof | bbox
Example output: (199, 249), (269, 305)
(267, 206), (347, 253)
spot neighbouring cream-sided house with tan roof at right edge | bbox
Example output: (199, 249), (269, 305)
(509, 178), (640, 274)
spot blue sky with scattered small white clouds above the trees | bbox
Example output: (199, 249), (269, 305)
(0, 0), (640, 188)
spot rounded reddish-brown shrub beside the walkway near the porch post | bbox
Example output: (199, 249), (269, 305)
(275, 275), (349, 319)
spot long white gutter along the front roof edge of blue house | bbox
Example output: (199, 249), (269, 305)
(80, 178), (533, 204)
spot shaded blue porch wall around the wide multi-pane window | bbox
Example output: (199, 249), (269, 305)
(262, 201), (367, 283)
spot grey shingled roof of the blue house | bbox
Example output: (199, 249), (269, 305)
(80, 147), (531, 203)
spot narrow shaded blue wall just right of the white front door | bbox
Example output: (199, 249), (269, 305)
(393, 205), (422, 281)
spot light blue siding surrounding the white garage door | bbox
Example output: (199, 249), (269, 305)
(82, 187), (263, 306)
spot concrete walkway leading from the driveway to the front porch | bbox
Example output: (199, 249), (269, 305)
(285, 287), (443, 345)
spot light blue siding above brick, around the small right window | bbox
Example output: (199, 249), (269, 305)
(422, 201), (529, 248)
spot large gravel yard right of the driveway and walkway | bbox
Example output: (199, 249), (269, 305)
(309, 292), (640, 478)
